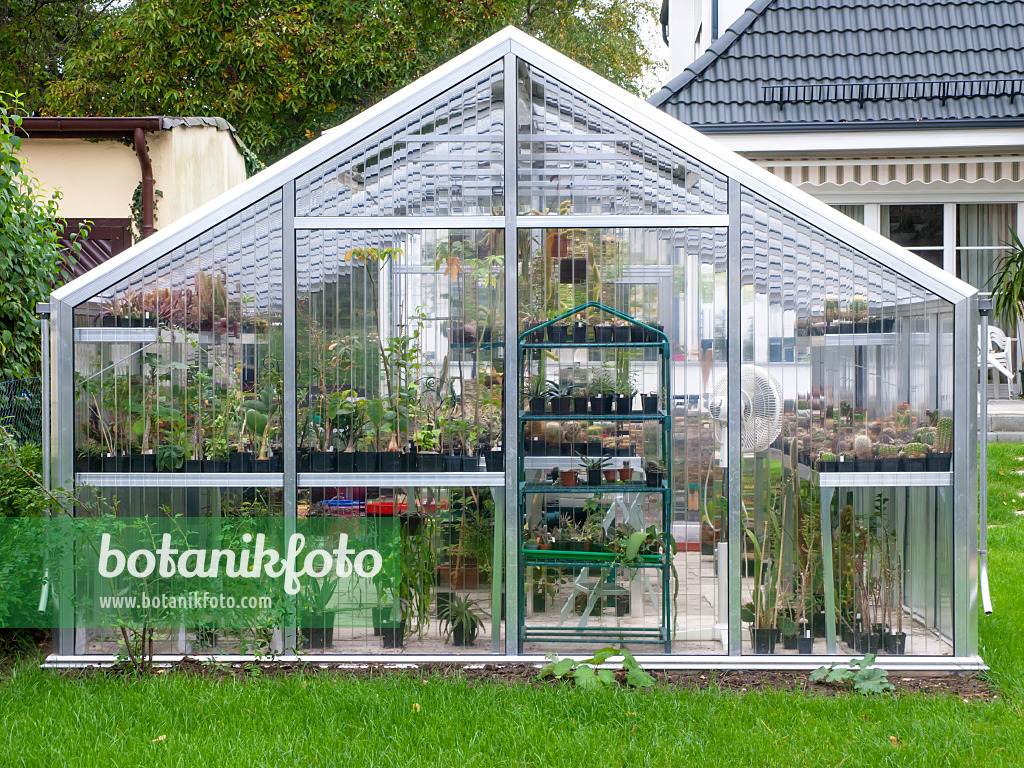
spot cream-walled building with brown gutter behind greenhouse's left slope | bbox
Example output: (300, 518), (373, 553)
(19, 117), (246, 274)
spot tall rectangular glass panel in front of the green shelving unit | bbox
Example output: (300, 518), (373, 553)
(518, 227), (727, 653)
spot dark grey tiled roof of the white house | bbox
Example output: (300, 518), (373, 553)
(649, 0), (1024, 130)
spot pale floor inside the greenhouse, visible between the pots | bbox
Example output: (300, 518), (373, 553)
(78, 551), (952, 656)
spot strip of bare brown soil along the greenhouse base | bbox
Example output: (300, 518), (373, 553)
(49, 656), (999, 701)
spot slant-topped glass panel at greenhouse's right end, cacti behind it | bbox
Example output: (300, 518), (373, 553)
(739, 190), (952, 653)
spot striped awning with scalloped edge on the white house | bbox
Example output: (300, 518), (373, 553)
(758, 157), (1024, 186)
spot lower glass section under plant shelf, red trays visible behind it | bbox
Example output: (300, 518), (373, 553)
(298, 487), (502, 654)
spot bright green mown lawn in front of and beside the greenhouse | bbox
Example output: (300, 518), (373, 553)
(0, 445), (1024, 768)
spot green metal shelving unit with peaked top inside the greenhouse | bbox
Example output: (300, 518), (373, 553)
(517, 301), (673, 653)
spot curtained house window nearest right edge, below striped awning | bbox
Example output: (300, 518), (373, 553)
(956, 203), (1017, 291)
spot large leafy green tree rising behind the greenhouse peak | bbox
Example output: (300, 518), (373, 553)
(47, 0), (654, 162)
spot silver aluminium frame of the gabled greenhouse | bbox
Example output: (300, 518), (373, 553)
(44, 28), (982, 670)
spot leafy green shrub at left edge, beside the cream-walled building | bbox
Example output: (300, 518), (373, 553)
(0, 92), (79, 381)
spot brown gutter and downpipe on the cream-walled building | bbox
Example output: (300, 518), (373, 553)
(16, 117), (167, 239)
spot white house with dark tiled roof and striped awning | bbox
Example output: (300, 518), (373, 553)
(649, 0), (1024, 289)
